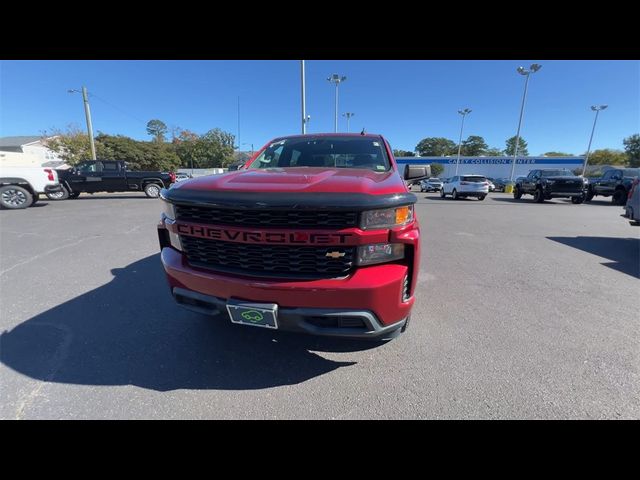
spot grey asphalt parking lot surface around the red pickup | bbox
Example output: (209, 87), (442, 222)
(0, 192), (640, 419)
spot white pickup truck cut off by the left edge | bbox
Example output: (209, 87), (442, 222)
(0, 166), (61, 210)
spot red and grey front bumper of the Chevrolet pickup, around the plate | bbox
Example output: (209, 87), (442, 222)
(161, 247), (414, 339)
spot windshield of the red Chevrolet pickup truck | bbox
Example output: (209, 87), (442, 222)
(249, 136), (390, 172)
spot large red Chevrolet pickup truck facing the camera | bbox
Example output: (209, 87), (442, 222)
(158, 134), (430, 340)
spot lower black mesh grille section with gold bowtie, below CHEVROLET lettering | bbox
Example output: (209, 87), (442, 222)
(180, 235), (355, 279)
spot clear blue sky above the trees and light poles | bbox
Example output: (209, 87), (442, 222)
(0, 59), (640, 155)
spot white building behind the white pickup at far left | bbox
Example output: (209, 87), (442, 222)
(0, 135), (64, 167)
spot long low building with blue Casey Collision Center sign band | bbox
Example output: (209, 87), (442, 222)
(396, 156), (584, 178)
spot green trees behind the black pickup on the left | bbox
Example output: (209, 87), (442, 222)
(44, 119), (235, 171)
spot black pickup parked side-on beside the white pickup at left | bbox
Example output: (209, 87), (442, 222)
(47, 160), (176, 200)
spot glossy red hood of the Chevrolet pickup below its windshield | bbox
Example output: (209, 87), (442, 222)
(172, 167), (407, 195)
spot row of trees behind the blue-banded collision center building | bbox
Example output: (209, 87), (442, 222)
(393, 133), (640, 167)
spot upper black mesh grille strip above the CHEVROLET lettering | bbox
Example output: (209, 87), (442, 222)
(176, 205), (358, 229)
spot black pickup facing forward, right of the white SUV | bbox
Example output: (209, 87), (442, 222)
(513, 168), (587, 203)
